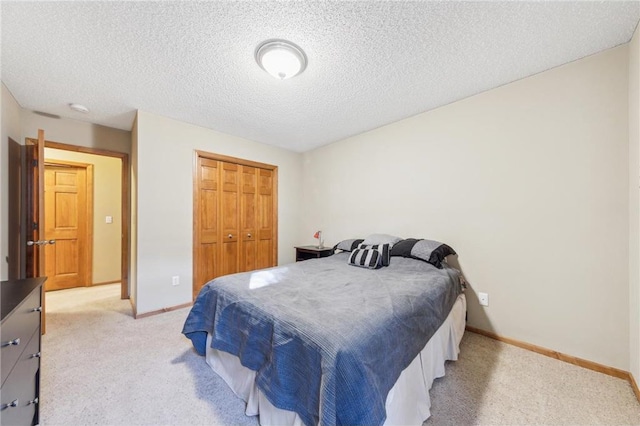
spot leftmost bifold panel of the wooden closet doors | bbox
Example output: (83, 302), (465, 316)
(193, 157), (221, 298)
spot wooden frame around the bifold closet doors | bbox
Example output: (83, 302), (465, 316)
(191, 149), (279, 300)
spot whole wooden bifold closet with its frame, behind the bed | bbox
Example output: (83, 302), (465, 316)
(193, 151), (278, 299)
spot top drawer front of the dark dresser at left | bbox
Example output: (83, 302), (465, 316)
(0, 287), (41, 385)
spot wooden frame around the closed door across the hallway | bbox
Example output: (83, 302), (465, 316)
(42, 161), (94, 287)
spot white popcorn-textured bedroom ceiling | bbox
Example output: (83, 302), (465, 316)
(1, 1), (640, 152)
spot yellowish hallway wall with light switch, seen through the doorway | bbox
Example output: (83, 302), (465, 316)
(44, 148), (122, 284)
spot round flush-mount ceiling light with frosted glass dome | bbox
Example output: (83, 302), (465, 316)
(256, 40), (307, 80)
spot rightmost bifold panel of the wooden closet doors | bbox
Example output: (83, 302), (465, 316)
(255, 169), (277, 269)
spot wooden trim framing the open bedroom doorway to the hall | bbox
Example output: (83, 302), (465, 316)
(44, 140), (131, 299)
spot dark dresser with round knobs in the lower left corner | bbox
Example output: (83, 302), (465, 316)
(0, 277), (46, 425)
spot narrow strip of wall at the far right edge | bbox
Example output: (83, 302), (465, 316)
(629, 28), (640, 383)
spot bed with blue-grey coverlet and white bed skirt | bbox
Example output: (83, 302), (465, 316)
(183, 236), (466, 425)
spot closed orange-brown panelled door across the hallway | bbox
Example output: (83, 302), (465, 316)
(44, 163), (92, 291)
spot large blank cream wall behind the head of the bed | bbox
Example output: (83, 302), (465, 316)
(301, 45), (629, 370)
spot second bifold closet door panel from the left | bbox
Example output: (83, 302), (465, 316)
(220, 162), (240, 275)
